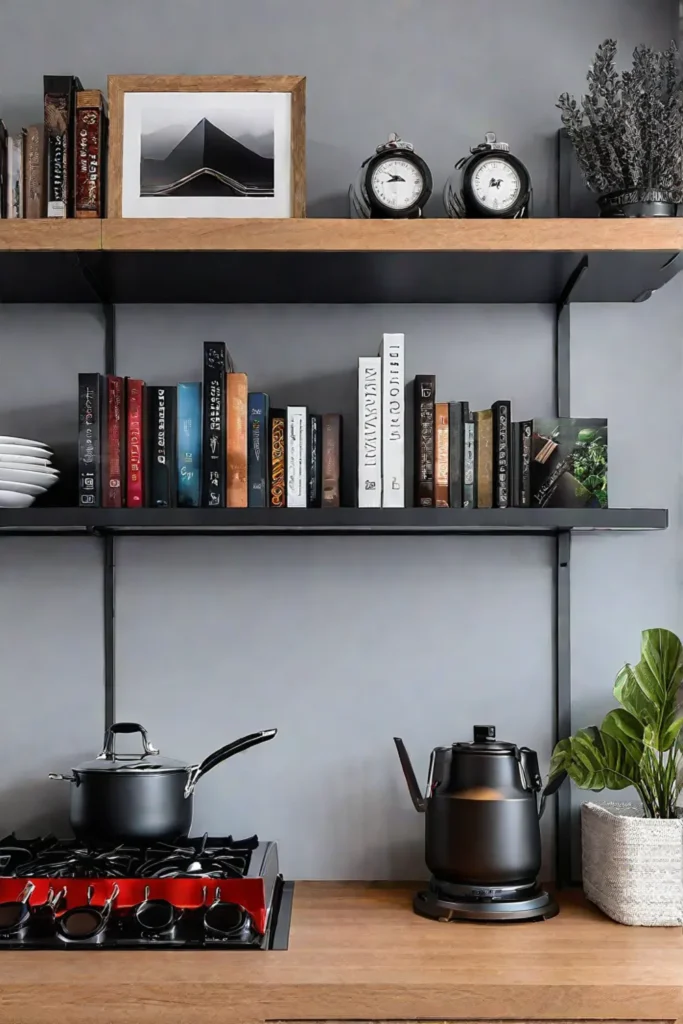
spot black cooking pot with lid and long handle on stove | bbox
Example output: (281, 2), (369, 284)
(49, 722), (278, 844)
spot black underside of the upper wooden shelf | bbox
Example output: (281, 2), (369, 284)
(0, 250), (681, 303)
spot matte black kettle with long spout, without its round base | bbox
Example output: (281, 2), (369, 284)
(394, 725), (545, 886)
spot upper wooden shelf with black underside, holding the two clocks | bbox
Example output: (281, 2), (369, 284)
(0, 218), (683, 303)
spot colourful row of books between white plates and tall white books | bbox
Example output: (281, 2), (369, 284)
(78, 342), (342, 508)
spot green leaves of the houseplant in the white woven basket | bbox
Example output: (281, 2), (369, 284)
(548, 630), (683, 818)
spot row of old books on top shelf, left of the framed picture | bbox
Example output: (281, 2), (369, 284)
(0, 75), (106, 219)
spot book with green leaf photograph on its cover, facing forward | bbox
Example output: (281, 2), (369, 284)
(531, 417), (608, 509)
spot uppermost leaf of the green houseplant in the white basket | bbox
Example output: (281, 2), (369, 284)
(614, 630), (683, 753)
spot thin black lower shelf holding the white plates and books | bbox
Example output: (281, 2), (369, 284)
(0, 508), (669, 536)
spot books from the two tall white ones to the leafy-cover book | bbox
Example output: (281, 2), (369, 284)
(357, 334), (607, 509)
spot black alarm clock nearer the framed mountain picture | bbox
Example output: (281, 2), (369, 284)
(349, 132), (432, 218)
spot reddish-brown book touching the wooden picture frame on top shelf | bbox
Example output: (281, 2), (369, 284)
(74, 89), (105, 217)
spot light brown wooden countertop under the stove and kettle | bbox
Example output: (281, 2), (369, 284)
(0, 883), (683, 1024)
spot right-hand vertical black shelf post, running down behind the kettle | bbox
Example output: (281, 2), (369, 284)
(554, 302), (571, 887)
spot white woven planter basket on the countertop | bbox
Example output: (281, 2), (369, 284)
(581, 804), (683, 927)
